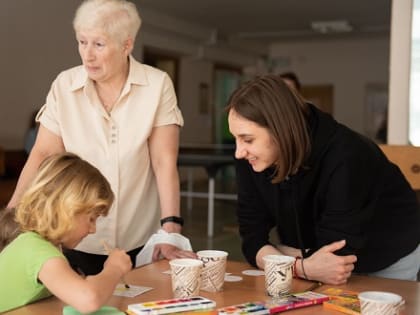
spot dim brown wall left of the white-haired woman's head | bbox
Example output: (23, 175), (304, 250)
(0, 0), (79, 149)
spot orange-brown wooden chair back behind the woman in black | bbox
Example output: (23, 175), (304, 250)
(379, 144), (420, 191)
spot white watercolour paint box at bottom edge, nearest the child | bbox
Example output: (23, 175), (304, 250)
(127, 296), (216, 315)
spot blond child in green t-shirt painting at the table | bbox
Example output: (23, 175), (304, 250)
(0, 153), (131, 313)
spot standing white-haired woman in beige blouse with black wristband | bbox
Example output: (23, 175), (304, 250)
(8, 0), (195, 274)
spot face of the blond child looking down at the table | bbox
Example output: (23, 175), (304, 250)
(61, 213), (98, 249)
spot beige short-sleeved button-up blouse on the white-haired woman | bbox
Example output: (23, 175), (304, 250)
(38, 56), (183, 254)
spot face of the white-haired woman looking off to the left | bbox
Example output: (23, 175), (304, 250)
(77, 30), (131, 83)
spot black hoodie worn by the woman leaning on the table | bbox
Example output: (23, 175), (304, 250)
(236, 105), (420, 272)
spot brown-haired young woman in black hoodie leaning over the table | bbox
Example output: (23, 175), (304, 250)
(228, 75), (420, 284)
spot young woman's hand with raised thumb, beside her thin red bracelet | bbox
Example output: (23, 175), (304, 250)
(297, 240), (357, 285)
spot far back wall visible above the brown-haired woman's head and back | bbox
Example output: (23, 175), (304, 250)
(270, 38), (389, 133)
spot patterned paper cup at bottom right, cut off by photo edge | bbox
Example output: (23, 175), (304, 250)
(358, 291), (404, 315)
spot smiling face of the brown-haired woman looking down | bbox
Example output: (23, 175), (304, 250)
(228, 109), (279, 172)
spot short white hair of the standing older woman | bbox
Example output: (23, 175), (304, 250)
(73, 0), (141, 43)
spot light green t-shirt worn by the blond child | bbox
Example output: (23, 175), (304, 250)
(0, 232), (65, 313)
